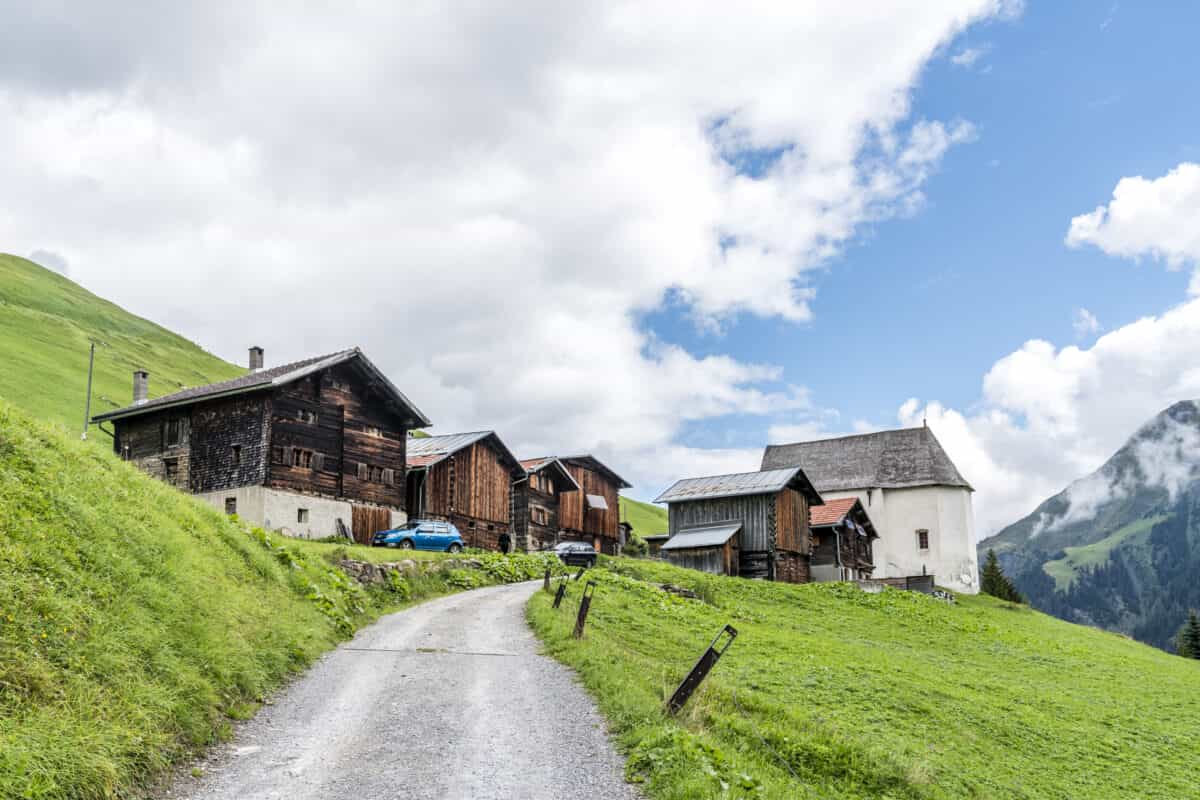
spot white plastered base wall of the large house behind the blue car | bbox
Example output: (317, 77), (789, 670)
(196, 486), (408, 539)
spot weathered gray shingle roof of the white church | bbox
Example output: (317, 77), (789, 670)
(762, 427), (974, 492)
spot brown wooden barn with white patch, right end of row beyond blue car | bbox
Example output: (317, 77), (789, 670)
(558, 456), (631, 555)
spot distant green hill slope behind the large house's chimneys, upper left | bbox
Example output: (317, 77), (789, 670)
(0, 254), (245, 434)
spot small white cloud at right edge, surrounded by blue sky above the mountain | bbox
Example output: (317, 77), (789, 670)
(1067, 162), (1200, 294)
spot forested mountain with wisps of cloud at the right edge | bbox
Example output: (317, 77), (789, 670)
(979, 401), (1200, 649)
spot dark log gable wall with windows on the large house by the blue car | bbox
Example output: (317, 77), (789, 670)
(268, 365), (408, 509)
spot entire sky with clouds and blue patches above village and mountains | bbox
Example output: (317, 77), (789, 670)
(0, 0), (1200, 534)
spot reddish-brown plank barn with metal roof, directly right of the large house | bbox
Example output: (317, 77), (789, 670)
(404, 431), (524, 551)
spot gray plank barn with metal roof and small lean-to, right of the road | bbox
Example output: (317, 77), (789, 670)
(655, 467), (823, 583)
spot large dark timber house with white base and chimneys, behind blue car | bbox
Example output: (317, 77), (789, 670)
(92, 348), (430, 541)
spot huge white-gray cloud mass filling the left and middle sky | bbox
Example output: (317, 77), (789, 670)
(0, 0), (1019, 492)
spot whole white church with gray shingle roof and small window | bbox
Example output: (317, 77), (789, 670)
(762, 427), (979, 594)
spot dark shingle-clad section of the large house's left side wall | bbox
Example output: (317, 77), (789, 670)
(188, 392), (270, 493)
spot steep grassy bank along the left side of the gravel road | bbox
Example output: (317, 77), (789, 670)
(0, 399), (560, 799)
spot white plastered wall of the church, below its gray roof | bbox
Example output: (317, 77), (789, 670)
(821, 486), (979, 594)
